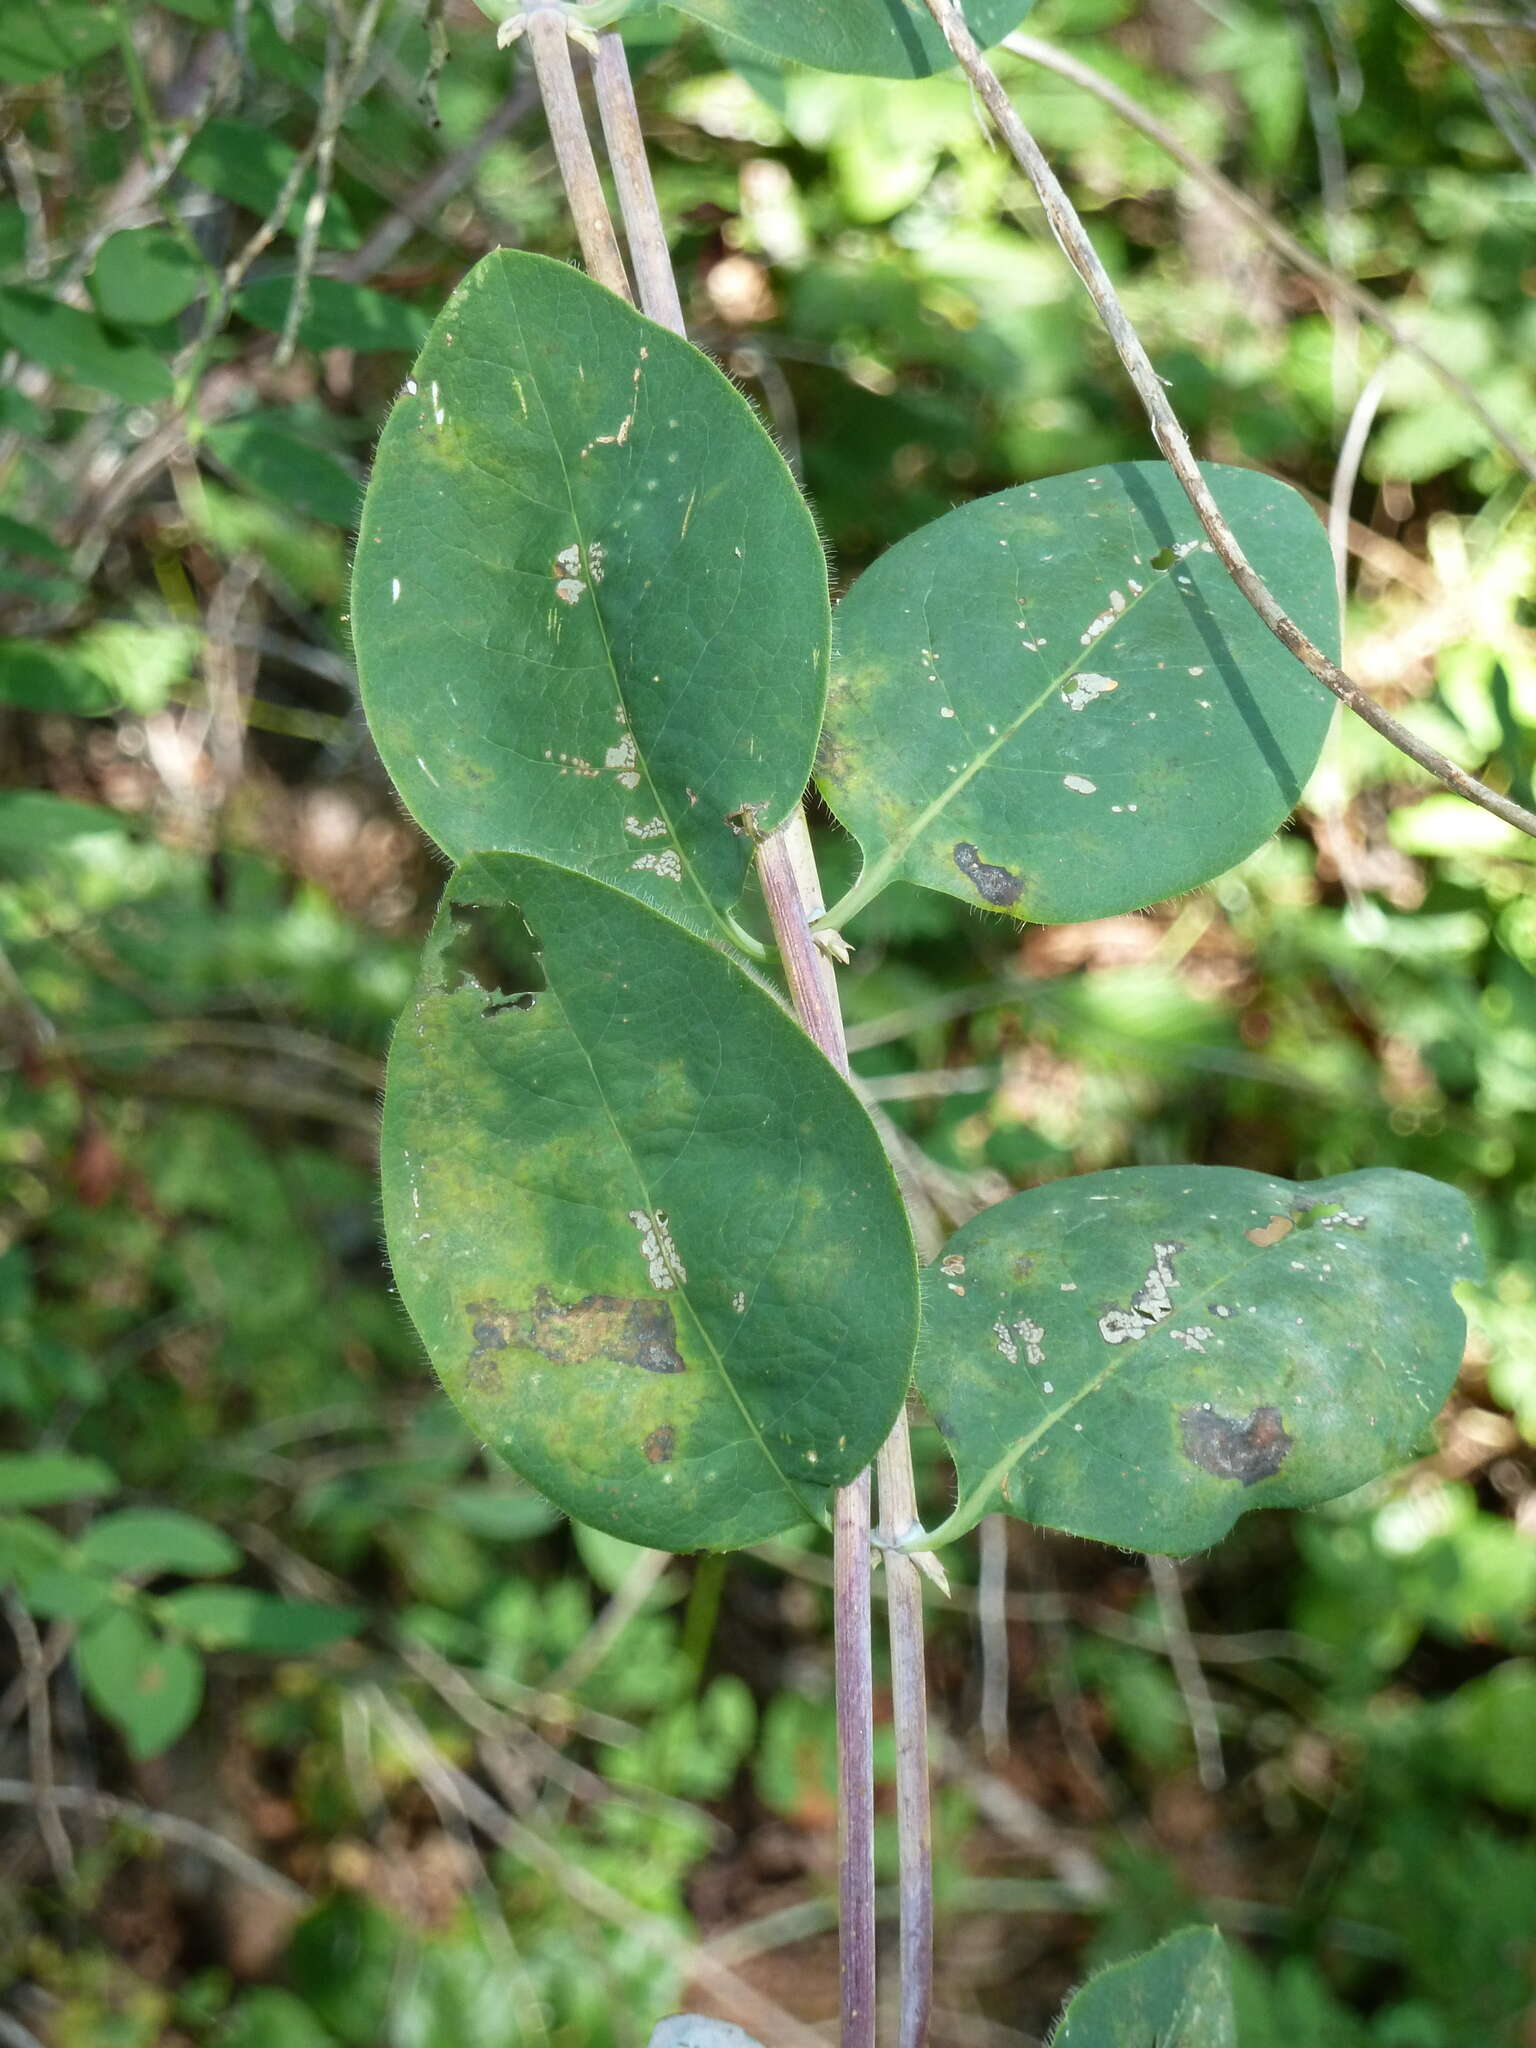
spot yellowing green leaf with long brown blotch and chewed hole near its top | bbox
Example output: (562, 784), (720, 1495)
(383, 854), (915, 1550)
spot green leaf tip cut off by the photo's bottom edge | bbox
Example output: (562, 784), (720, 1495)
(1051, 1927), (1237, 2048)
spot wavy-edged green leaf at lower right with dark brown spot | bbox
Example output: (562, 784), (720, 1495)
(918, 1165), (1479, 1552)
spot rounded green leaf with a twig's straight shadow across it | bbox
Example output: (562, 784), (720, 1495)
(817, 463), (1337, 924)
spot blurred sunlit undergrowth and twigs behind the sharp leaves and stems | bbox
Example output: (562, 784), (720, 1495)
(0, 0), (1536, 2048)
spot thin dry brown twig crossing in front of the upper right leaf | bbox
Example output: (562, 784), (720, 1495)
(926, 0), (1536, 838)
